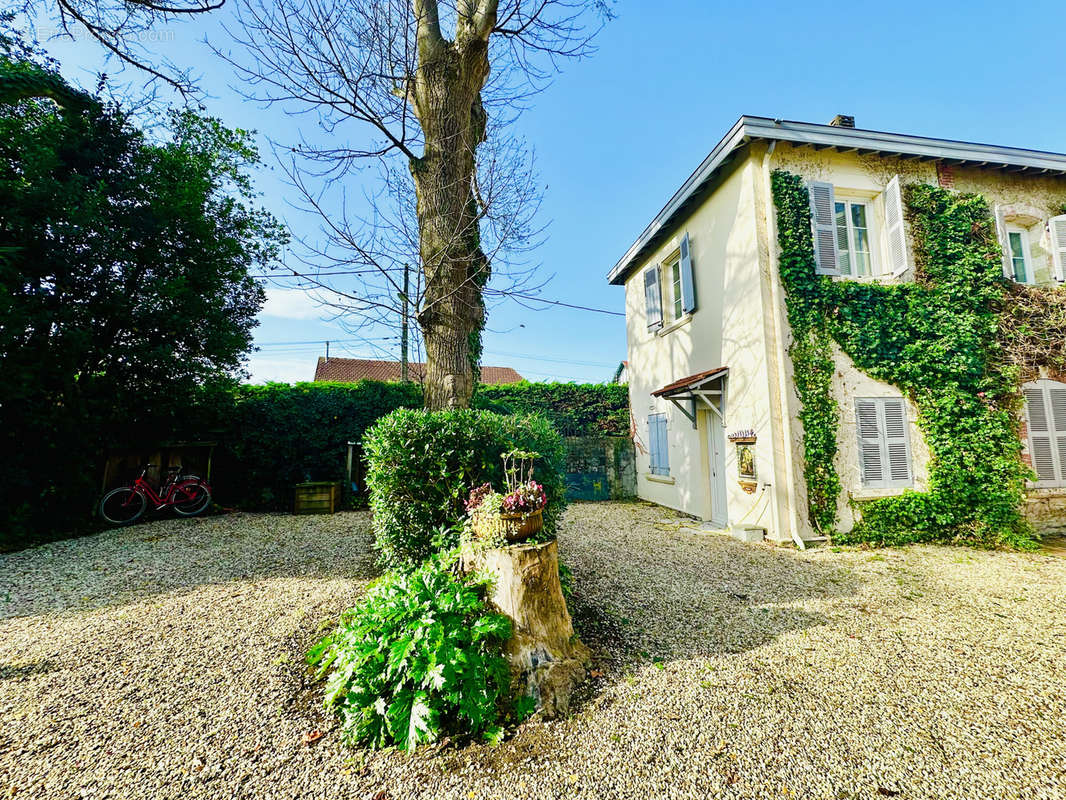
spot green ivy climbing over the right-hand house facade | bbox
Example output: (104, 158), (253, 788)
(772, 171), (1044, 548)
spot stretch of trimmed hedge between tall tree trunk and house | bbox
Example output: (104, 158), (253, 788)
(475, 382), (629, 436)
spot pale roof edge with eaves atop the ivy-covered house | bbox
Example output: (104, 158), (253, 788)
(608, 116), (1066, 285)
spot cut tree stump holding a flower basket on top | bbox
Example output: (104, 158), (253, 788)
(463, 542), (592, 718)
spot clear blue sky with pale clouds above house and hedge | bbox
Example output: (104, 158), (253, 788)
(25, 0), (1066, 381)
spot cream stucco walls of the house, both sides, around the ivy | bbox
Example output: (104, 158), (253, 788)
(626, 143), (1066, 541)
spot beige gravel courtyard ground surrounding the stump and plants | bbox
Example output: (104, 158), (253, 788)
(0, 503), (1066, 800)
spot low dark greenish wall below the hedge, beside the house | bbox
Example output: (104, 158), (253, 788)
(566, 436), (636, 500)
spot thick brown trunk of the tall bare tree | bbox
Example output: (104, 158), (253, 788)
(410, 38), (489, 410)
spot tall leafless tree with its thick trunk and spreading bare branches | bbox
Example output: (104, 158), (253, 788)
(221, 0), (610, 409)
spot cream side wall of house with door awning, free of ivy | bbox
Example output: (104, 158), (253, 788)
(626, 153), (772, 528)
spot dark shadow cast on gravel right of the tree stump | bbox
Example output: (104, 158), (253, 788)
(563, 514), (858, 673)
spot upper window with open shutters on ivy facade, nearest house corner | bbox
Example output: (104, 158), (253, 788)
(807, 175), (909, 277)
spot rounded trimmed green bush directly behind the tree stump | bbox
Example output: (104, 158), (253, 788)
(364, 409), (566, 569)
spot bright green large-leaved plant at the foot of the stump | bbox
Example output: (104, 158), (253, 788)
(307, 554), (511, 750)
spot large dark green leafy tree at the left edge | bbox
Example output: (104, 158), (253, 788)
(0, 53), (285, 547)
